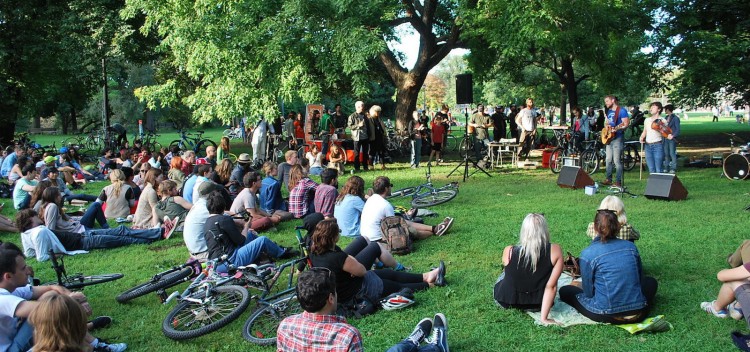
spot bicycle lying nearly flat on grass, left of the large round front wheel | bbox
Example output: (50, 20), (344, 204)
(115, 259), (202, 303)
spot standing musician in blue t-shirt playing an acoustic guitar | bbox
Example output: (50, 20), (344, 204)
(602, 95), (630, 187)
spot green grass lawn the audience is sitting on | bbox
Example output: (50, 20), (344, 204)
(5, 117), (750, 352)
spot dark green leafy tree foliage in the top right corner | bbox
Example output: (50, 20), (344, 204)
(654, 0), (750, 107)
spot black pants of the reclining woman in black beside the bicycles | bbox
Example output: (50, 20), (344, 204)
(344, 236), (430, 297)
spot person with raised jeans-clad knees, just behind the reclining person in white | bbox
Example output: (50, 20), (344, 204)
(39, 187), (109, 233)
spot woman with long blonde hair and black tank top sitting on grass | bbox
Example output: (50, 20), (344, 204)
(494, 214), (563, 324)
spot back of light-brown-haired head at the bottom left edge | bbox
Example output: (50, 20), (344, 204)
(29, 291), (91, 352)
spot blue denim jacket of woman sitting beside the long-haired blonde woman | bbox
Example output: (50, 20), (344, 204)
(577, 237), (647, 314)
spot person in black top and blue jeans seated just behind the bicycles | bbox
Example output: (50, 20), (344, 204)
(203, 191), (299, 266)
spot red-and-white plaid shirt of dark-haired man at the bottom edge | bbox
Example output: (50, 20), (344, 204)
(276, 312), (364, 352)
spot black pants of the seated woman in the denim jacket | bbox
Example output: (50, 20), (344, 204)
(560, 276), (659, 324)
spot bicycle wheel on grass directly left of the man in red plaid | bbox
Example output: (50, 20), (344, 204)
(242, 294), (302, 346)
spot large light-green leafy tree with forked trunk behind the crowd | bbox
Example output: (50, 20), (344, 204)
(125, 0), (472, 129)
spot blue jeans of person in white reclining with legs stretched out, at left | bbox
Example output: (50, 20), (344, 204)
(82, 225), (162, 250)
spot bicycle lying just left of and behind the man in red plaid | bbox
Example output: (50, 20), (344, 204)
(242, 226), (312, 346)
